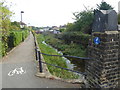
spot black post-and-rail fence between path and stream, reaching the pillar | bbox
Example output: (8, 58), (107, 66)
(33, 34), (91, 75)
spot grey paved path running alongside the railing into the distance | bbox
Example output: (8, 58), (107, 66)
(2, 33), (80, 88)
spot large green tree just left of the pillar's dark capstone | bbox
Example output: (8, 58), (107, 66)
(66, 9), (93, 34)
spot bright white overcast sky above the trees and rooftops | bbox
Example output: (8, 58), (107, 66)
(6, 0), (120, 27)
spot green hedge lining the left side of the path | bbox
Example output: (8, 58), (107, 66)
(0, 30), (29, 56)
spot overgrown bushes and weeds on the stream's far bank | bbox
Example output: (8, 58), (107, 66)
(44, 33), (90, 57)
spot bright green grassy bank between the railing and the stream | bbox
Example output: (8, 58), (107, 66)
(36, 34), (78, 79)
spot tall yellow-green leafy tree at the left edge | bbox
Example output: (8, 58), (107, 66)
(0, 1), (12, 55)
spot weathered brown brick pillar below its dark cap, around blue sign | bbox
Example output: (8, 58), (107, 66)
(85, 31), (120, 88)
